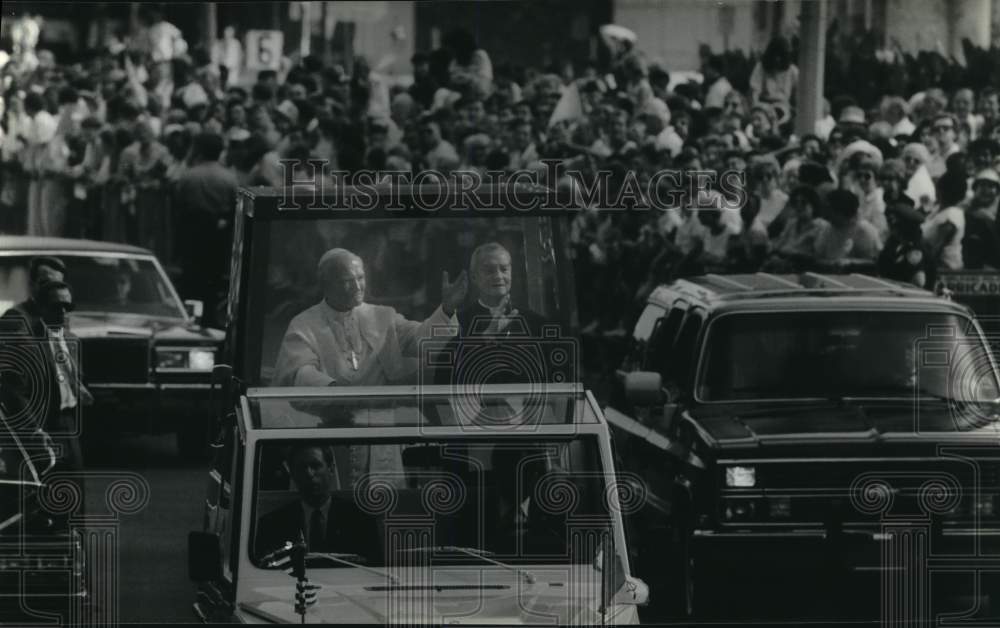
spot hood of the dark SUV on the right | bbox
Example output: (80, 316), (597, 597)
(692, 400), (1000, 447)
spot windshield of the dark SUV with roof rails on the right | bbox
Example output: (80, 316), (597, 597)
(697, 310), (1000, 402)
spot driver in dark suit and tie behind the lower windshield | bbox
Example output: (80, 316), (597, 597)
(254, 444), (381, 561)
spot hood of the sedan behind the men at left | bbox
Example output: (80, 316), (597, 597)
(69, 312), (224, 342)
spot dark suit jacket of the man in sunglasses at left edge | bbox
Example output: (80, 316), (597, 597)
(0, 300), (90, 431)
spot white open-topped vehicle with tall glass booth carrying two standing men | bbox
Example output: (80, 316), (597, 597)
(189, 186), (648, 624)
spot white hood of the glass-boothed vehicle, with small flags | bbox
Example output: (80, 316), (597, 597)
(239, 566), (636, 625)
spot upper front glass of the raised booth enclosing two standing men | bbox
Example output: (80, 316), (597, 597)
(254, 216), (577, 386)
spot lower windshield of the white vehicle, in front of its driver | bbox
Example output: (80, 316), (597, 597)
(250, 434), (611, 568)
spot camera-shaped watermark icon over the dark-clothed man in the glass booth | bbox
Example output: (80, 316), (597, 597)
(418, 317), (580, 431)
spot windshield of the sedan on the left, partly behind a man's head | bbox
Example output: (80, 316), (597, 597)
(0, 253), (185, 319)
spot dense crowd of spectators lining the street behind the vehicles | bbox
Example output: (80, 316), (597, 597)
(0, 5), (1000, 333)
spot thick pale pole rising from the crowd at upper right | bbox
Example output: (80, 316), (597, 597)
(795, 0), (826, 137)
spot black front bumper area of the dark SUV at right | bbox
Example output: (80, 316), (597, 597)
(691, 522), (1000, 620)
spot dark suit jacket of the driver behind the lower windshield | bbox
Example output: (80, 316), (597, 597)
(254, 497), (382, 562)
